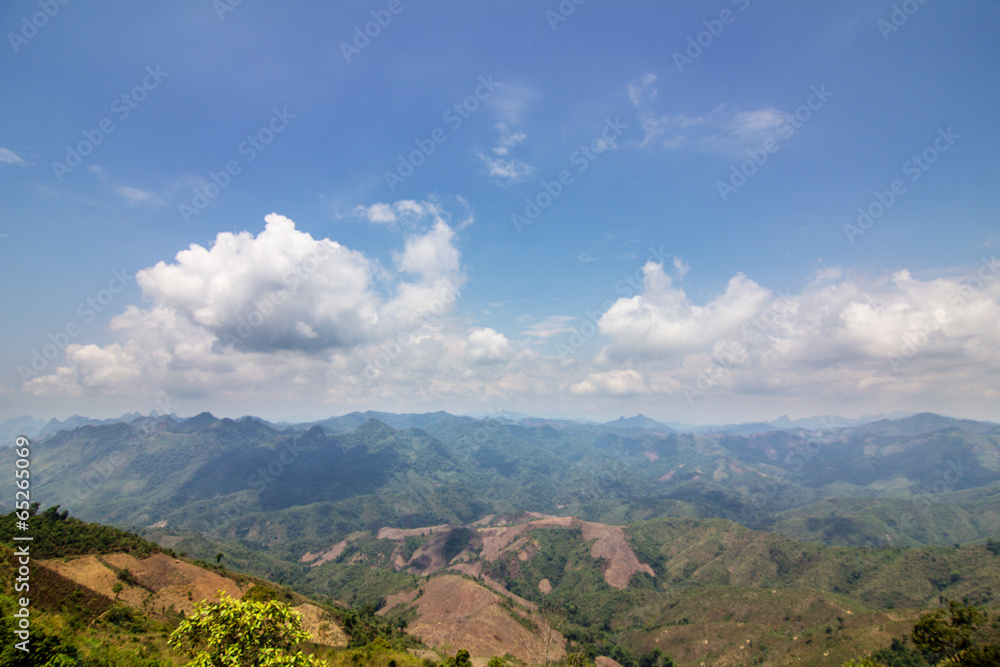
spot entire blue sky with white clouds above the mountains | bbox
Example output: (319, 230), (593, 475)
(0, 0), (1000, 421)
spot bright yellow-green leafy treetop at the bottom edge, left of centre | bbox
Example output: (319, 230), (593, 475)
(169, 591), (322, 667)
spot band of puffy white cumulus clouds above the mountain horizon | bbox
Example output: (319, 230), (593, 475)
(22, 207), (1000, 418)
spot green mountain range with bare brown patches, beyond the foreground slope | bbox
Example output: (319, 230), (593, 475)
(0, 412), (1000, 667)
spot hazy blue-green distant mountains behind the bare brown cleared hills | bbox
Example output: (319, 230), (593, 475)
(0, 412), (1000, 553)
